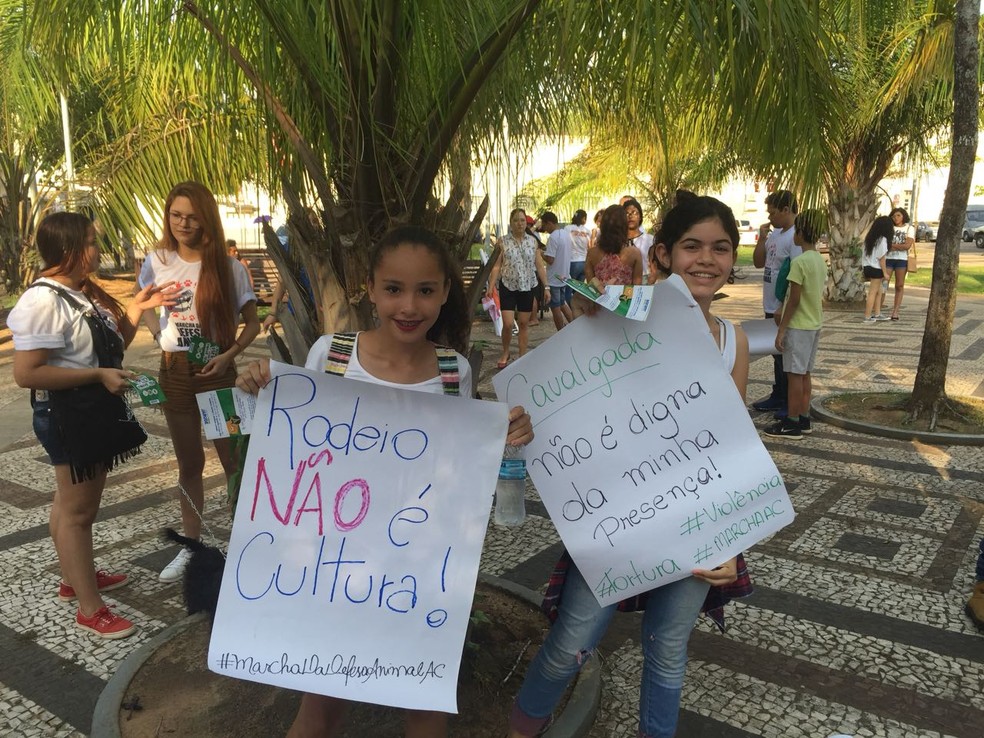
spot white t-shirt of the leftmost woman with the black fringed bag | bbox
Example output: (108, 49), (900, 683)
(7, 278), (119, 369)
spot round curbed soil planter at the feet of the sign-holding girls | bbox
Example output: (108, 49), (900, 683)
(91, 575), (601, 738)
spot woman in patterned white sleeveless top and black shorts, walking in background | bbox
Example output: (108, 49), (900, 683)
(485, 208), (547, 369)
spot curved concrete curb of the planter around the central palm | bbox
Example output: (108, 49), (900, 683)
(89, 572), (601, 738)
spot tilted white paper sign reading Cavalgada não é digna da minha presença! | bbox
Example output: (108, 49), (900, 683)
(493, 277), (793, 604)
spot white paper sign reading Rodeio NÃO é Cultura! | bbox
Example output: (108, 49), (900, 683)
(208, 362), (507, 712)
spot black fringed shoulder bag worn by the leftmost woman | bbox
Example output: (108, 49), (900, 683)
(31, 282), (147, 484)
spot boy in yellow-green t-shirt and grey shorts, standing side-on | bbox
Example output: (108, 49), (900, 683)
(765, 211), (827, 440)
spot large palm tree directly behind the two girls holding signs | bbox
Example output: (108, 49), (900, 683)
(23, 0), (830, 348)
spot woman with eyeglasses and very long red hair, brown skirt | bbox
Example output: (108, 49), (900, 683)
(139, 182), (260, 582)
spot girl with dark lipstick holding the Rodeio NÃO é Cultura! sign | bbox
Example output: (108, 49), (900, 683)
(236, 224), (533, 738)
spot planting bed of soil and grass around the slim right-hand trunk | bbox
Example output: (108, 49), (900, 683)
(823, 392), (984, 435)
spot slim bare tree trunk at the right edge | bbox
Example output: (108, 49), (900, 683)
(909, 0), (980, 430)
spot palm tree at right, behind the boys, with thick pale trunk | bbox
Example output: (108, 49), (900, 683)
(776, 0), (976, 302)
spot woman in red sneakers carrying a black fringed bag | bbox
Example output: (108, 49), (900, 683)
(7, 213), (172, 639)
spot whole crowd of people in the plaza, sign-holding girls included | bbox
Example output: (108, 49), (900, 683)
(7, 182), (984, 738)
